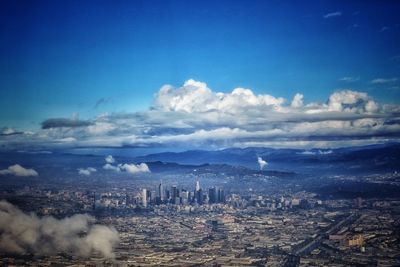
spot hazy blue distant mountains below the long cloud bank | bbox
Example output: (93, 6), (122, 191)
(134, 143), (400, 174)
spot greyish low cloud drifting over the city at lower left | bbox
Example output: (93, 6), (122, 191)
(0, 200), (119, 258)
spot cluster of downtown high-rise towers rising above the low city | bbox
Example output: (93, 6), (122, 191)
(141, 181), (225, 207)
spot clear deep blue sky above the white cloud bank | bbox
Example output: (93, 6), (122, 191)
(0, 1), (400, 151)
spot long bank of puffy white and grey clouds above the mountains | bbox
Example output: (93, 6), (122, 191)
(0, 79), (400, 151)
